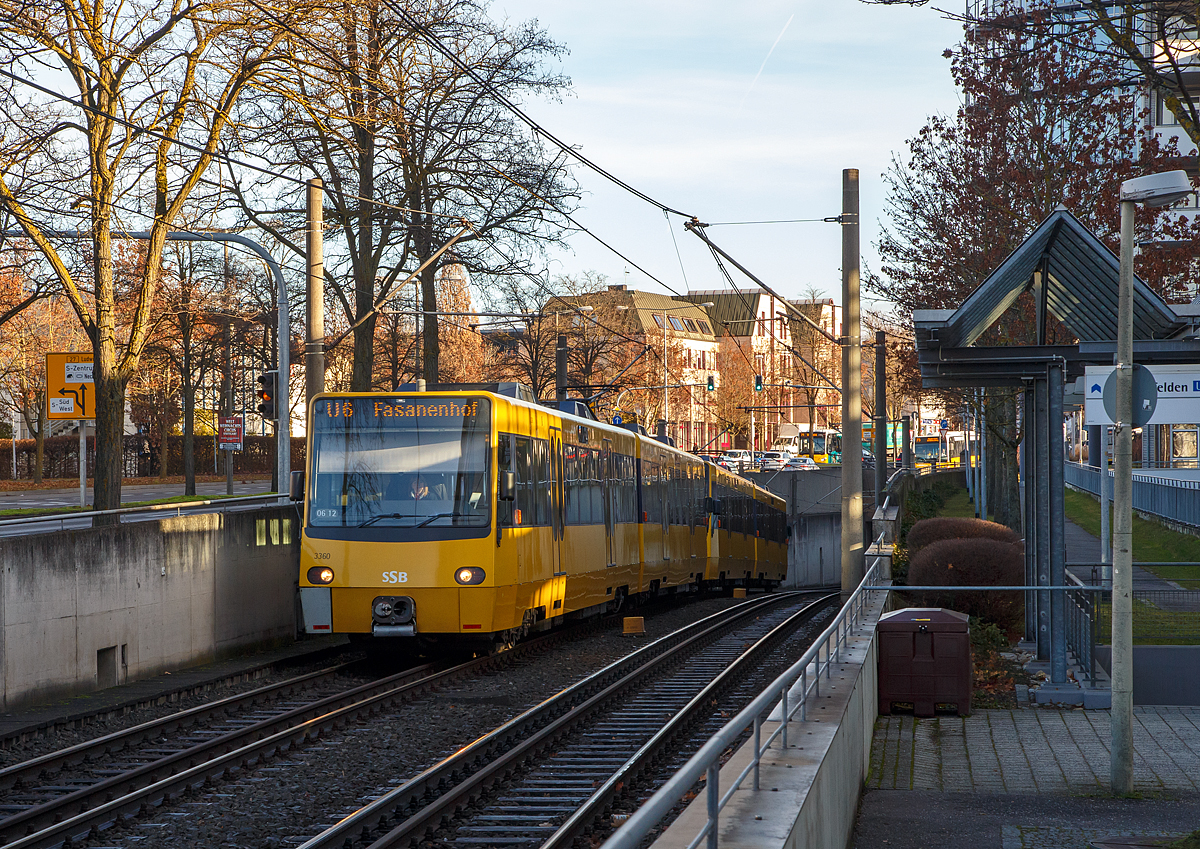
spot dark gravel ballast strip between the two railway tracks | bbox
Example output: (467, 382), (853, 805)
(60, 597), (772, 849)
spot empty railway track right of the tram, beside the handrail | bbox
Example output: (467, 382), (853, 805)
(290, 594), (834, 849)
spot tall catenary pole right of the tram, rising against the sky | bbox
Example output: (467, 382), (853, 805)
(839, 168), (863, 598)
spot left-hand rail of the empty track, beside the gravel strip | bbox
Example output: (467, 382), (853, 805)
(290, 594), (799, 849)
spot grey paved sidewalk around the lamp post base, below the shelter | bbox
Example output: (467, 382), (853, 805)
(852, 708), (1200, 849)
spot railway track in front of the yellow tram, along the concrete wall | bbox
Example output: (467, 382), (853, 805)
(0, 624), (619, 849)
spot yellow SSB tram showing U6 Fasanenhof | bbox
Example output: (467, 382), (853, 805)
(299, 384), (787, 648)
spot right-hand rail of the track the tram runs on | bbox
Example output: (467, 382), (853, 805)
(0, 618), (592, 849)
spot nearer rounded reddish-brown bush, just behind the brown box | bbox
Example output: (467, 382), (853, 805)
(908, 537), (1025, 637)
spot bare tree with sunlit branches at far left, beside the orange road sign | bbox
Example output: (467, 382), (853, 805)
(0, 0), (288, 508)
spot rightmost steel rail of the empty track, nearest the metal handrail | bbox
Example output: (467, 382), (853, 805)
(541, 594), (840, 849)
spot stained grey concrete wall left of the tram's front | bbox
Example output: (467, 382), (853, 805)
(0, 507), (298, 708)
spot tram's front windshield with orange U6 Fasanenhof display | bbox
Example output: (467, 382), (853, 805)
(308, 397), (491, 528)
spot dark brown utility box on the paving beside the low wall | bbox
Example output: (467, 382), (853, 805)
(877, 607), (972, 716)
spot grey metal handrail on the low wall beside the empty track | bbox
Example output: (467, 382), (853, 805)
(601, 554), (890, 849)
